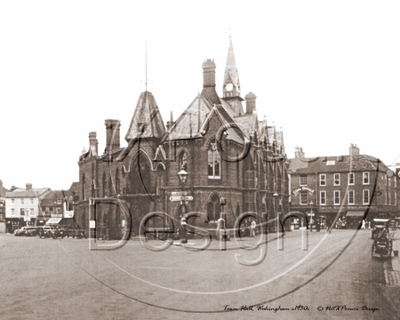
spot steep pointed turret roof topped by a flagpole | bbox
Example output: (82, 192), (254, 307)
(125, 91), (165, 142)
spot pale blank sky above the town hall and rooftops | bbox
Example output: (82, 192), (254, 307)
(0, 0), (400, 190)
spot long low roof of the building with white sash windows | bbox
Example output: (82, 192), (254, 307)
(289, 154), (389, 174)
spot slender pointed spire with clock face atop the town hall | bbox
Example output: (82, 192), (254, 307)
(222, 37), (244, 116)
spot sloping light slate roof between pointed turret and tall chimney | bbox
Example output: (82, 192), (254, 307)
(169, 95), (212, 140)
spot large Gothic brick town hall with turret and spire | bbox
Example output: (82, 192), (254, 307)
(75, 40), (289, 238)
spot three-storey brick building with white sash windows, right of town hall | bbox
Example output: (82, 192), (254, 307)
(289, 145), (399, 228)
